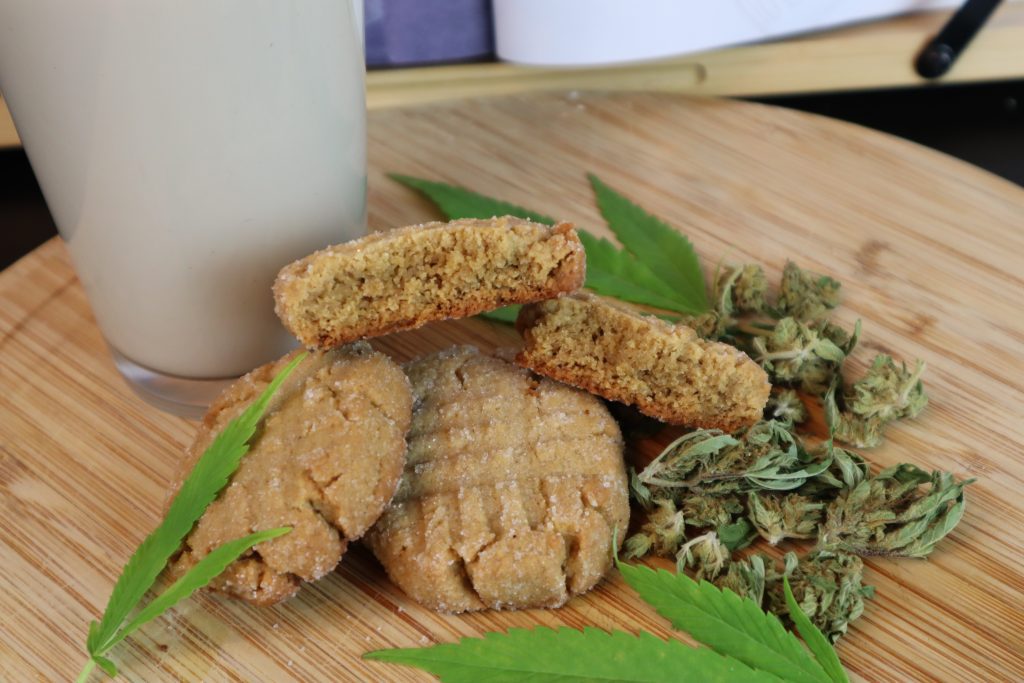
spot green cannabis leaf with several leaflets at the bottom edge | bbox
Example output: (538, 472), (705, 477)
(364, 563), (846, 683)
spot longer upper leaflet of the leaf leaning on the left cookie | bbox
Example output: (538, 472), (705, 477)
(87, 353), (305, 667)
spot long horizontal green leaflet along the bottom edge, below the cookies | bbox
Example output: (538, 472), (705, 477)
(362, 627), (784, 683)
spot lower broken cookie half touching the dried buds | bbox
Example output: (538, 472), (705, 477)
(516, 294), (771, 431)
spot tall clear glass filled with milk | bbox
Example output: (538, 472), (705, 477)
(0, 0), (366, 416)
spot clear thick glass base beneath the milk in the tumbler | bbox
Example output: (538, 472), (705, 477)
(111, 347), (238, 420)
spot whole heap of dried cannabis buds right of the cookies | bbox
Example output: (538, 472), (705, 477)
(626, 262), (954, 641)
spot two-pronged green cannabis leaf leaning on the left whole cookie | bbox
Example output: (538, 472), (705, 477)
(80, 353), (305, 680)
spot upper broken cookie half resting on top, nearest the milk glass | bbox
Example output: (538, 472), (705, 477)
(273, 216), (586, 348)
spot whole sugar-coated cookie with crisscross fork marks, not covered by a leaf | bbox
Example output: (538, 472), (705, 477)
(367, 347), (629, 612)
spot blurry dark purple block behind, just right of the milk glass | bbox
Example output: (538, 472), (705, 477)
(364, 0), (495, 67)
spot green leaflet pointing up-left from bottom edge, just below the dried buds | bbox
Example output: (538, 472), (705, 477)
(618, 563), (829, 683)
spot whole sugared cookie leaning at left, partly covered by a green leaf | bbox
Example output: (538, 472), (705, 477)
(170, 342), (412, 605)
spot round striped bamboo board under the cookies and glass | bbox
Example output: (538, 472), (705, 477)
(0, 94), (1024, 681)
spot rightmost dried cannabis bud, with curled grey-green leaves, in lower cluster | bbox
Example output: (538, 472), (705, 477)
(817, 464), (974, 557)
